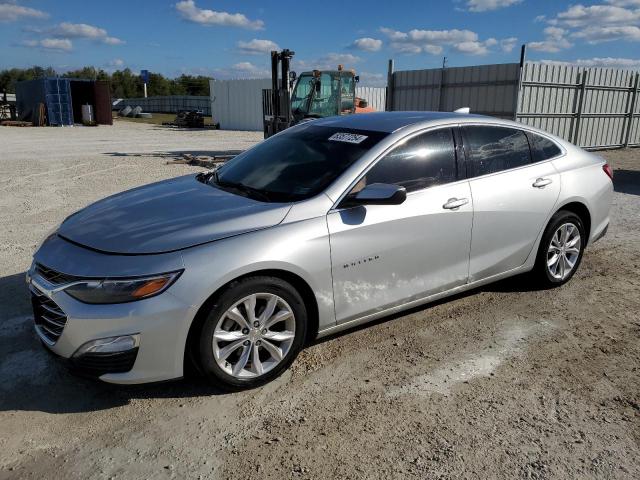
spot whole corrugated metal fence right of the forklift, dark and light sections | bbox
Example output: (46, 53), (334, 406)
(387, 62), (640, 149)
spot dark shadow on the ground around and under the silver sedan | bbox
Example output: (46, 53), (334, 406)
(0, 273), (544, 413)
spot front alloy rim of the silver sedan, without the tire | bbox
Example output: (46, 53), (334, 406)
(213, 293), (296, 378)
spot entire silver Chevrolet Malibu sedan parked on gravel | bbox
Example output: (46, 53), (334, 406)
(27, 112), (613, 389)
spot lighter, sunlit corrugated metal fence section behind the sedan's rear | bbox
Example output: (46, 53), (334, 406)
(516, 62), (640, 149)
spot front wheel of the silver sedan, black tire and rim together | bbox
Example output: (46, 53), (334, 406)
(197, 276), (307, 391)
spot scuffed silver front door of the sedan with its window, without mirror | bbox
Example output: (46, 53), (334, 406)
(327, 129), (473, 323)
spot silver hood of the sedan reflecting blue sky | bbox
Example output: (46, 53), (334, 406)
(58, 175), (291, 254)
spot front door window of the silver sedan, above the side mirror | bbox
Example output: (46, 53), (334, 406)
(359, 128), (457, 192)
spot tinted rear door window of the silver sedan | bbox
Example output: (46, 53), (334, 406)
(464, 126), (531, 177)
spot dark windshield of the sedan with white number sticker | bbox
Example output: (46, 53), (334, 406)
(210, 122), (387, 202)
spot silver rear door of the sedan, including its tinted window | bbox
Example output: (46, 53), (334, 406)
(462, 125), (560, 282)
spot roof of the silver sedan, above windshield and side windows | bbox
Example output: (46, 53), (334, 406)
(313, 112), (514, 133)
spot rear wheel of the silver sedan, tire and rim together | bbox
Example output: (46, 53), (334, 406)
(533, 210), (587, 288)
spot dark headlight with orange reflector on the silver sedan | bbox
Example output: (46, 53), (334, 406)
(64, 271), (182, 303)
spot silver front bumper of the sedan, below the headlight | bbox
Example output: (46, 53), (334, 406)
(27, 268), (195, 384)
